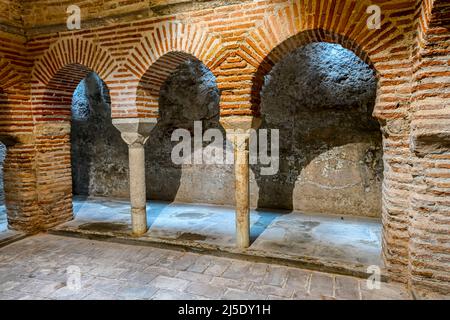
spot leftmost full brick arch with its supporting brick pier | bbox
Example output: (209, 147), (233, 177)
(31, 38), (115, 229)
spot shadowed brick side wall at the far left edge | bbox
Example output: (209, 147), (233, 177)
(0, 27), (41, 231)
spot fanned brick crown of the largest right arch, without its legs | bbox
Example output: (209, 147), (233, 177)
(245, 0), (404, 66)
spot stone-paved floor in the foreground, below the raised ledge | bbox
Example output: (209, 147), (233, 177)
(0, 234), (411, 300)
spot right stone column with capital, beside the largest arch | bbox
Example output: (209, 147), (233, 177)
(220, 116), (261, 249)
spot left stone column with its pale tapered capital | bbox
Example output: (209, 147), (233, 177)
(113, 118), (156, 236)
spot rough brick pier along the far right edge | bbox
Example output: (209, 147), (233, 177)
(409, 0), (450, 293)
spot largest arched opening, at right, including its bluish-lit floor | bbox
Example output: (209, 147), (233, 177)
(251, 41), (383, 265)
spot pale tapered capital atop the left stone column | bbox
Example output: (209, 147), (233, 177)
(112, 118), (157, 147)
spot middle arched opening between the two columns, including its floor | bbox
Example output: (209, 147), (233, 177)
(139, 56), (234, 232)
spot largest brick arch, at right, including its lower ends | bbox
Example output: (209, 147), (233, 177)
(219, 0), (410, 118)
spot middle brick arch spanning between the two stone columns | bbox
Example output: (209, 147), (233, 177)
(122, 22), (222, 118)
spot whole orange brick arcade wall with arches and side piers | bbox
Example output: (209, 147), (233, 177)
(0, 0), (450, 293)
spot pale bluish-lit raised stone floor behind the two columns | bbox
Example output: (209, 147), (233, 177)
(58, 198), (382, 267)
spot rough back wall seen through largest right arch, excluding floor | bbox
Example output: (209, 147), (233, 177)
(254, 42), (383, 217)
